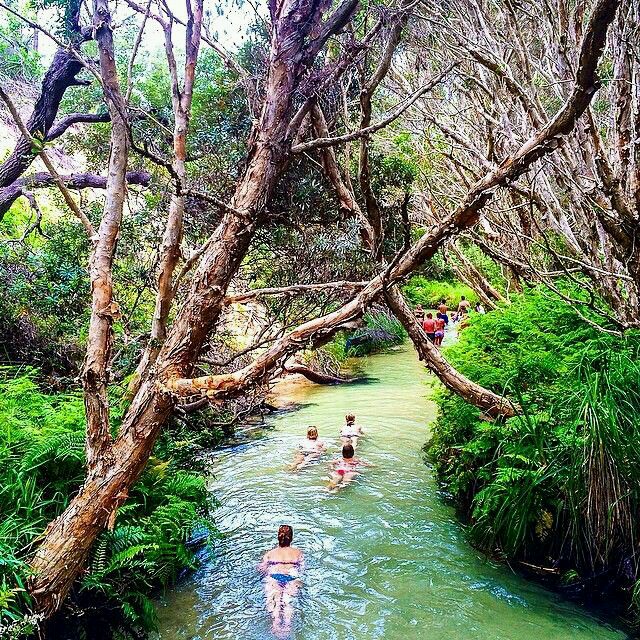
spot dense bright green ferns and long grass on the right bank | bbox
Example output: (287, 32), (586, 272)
(426, 289), (640, 618)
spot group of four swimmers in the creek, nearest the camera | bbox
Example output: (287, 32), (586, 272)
(258, 413), (372, 638)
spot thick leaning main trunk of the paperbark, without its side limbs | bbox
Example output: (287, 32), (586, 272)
(30, 0), (344, 615)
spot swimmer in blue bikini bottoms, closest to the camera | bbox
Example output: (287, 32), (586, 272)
(258, 524), (304, 638)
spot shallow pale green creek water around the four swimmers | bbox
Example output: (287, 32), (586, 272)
(159, 351), (624, 640)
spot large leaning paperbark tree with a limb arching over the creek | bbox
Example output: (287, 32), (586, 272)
(25, 0), (618, 614)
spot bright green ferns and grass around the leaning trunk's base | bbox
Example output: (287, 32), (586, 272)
(0, 368), (213, 640)
